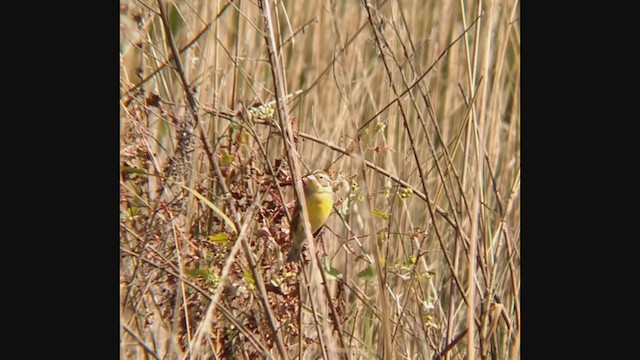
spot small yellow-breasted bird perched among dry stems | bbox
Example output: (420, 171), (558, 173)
(287, 170), (333, 262)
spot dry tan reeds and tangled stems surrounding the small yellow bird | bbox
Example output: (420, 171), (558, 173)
(120, 0), (520, 359)
